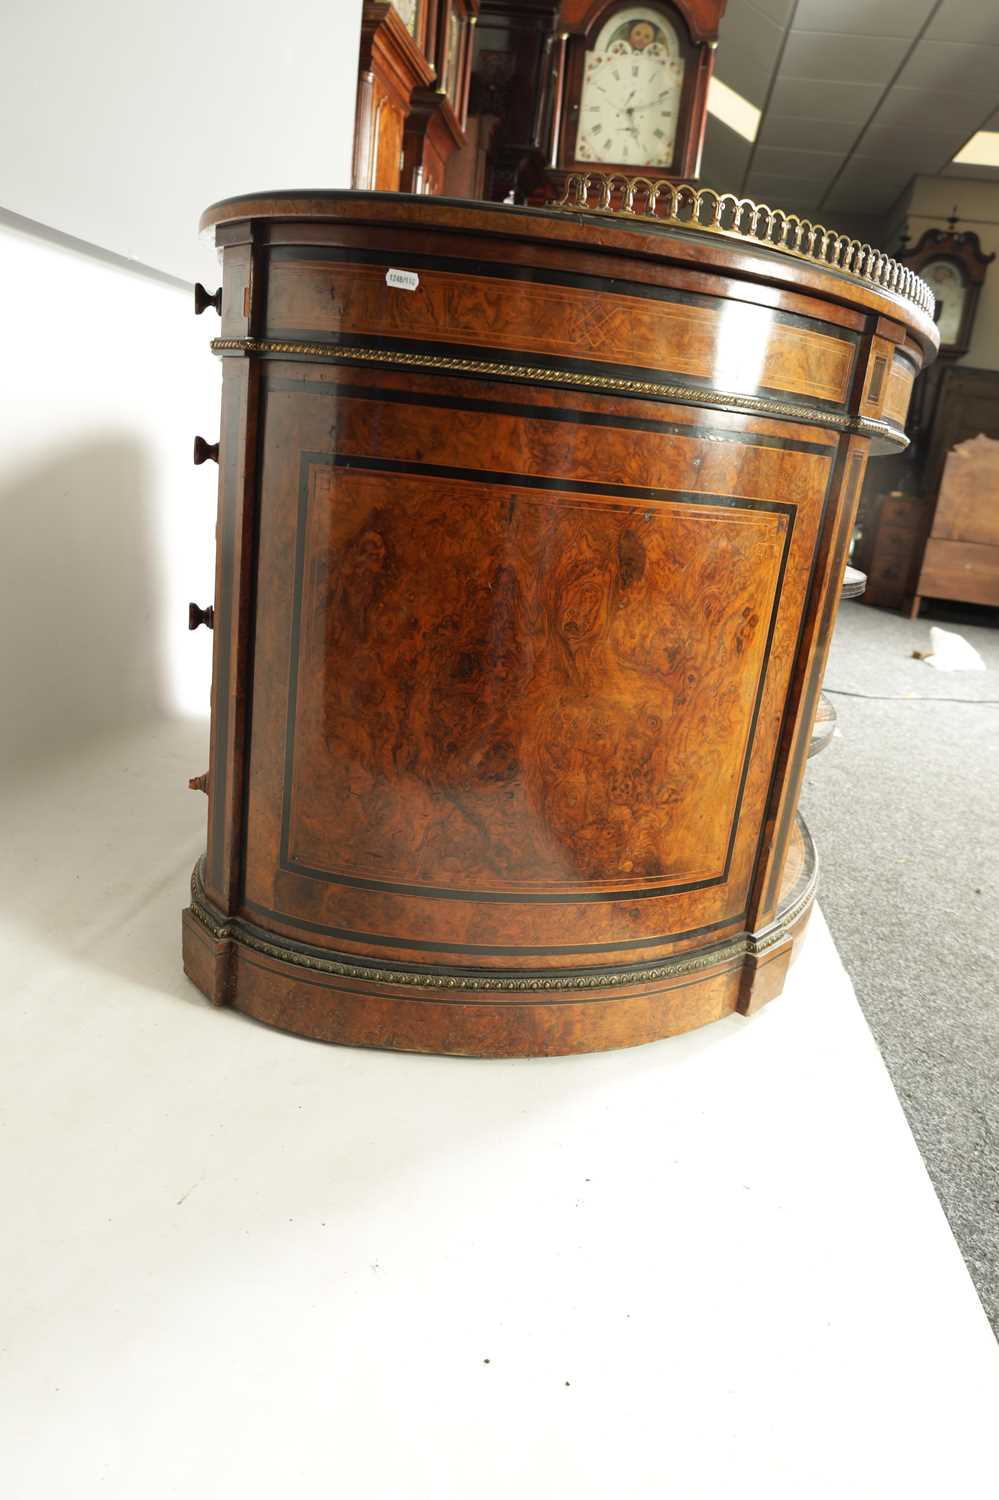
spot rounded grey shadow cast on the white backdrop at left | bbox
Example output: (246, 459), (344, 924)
(0, 432), (167, 767)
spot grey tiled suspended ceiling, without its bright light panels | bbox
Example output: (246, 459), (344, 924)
(702, 0), (999, 225)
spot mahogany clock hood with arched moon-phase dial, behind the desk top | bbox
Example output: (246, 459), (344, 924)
(551, 0), (725, 186)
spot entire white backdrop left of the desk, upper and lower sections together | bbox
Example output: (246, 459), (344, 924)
(0, 0), (362, 761)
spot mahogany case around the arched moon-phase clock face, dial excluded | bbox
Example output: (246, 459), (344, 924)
(549, 0), (725, 197)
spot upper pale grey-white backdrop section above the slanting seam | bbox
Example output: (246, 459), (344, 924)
(0, 0), (362, 281)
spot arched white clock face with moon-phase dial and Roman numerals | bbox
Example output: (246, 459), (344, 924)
(575, 6), (684, 168)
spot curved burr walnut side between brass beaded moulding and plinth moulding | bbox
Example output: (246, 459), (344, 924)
(246, 363), (837, 968)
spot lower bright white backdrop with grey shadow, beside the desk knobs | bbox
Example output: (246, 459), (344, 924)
(0, 219), (219, 758)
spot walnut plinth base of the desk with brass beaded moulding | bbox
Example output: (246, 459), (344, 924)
(183, 819), (818, 1058)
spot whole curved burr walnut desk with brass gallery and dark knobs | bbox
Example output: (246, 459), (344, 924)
(183, 179), (936, 1056)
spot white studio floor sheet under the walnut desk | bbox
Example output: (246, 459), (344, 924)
(0, 722), (999, 1500)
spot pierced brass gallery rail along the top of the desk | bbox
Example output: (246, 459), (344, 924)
(552, 173), (935, 318)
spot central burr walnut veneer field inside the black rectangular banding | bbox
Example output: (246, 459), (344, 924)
(285, 455), (794, 893)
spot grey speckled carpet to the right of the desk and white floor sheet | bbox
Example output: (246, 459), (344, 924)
(801, 603), (999, 1334)
